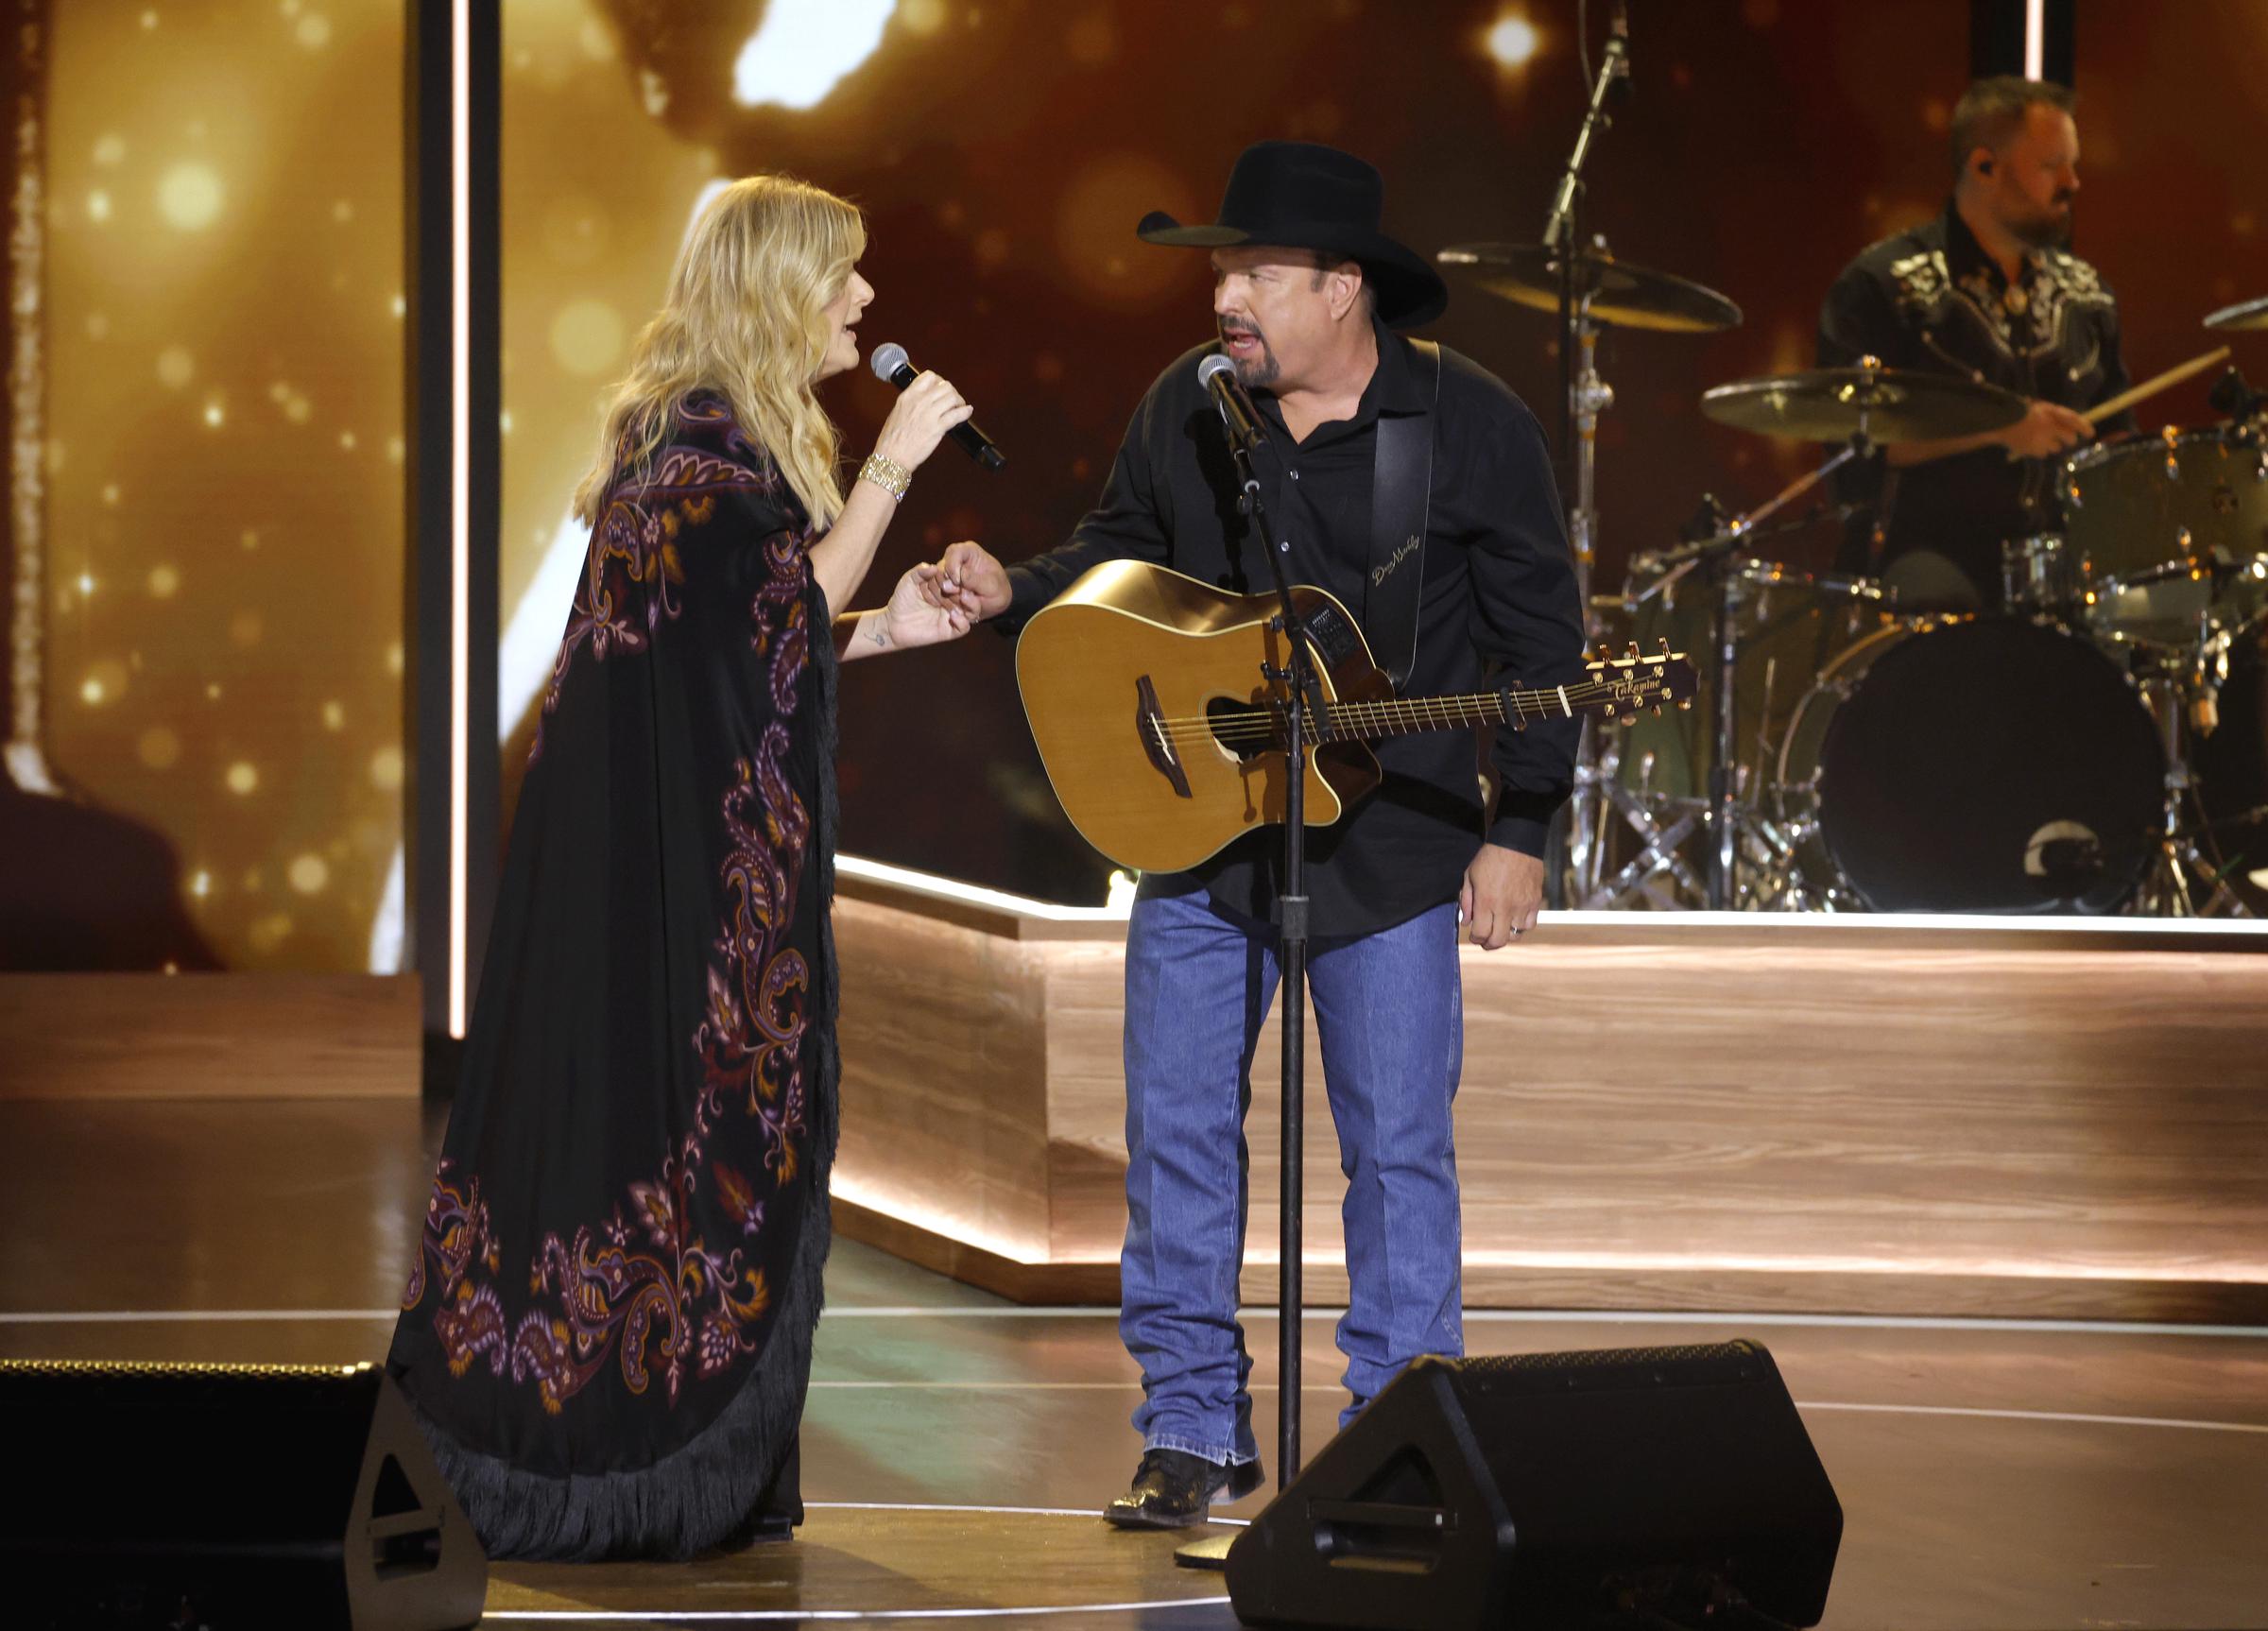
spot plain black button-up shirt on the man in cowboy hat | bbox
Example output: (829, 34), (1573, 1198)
(998, 327), (1583, 935)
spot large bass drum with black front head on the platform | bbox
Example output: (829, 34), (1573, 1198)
(1778, 617), (2164, 912)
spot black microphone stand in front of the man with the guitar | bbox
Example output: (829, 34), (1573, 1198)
(1175, 392), (1329, 1568)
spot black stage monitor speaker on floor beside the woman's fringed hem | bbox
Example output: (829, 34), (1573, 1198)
(0, 1359), (488, 1631)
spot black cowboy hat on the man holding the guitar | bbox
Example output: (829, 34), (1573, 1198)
(1134, 141), (1450, 329)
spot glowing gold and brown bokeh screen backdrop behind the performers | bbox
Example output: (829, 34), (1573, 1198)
(0, 0), (2268, 969)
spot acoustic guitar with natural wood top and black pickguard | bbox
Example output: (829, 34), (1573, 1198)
(1016, 560), (1696, 871)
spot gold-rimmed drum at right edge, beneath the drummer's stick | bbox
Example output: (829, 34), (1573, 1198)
(2062, 429), (2268, 644)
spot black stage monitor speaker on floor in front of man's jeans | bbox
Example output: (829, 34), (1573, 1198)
(1227, 1343), (1842, 1631)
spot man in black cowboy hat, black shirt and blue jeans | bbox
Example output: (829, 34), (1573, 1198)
(920, 141), (1583, 1527)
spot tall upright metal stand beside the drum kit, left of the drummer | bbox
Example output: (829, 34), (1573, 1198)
(1542, 25), (1631, 907)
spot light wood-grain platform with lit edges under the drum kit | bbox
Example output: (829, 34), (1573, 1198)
(834, 862), (2268, 1323)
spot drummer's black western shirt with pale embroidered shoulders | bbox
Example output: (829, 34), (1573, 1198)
(1819, 202), (2127, 606)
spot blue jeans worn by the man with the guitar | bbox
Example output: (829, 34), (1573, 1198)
(1118, 891), (1465, 1463)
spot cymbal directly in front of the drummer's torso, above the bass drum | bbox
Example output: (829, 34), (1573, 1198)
(1701, 368), (2025, 442)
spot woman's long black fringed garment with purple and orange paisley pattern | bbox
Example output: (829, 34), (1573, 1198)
(387, 395), (837, 1558)
